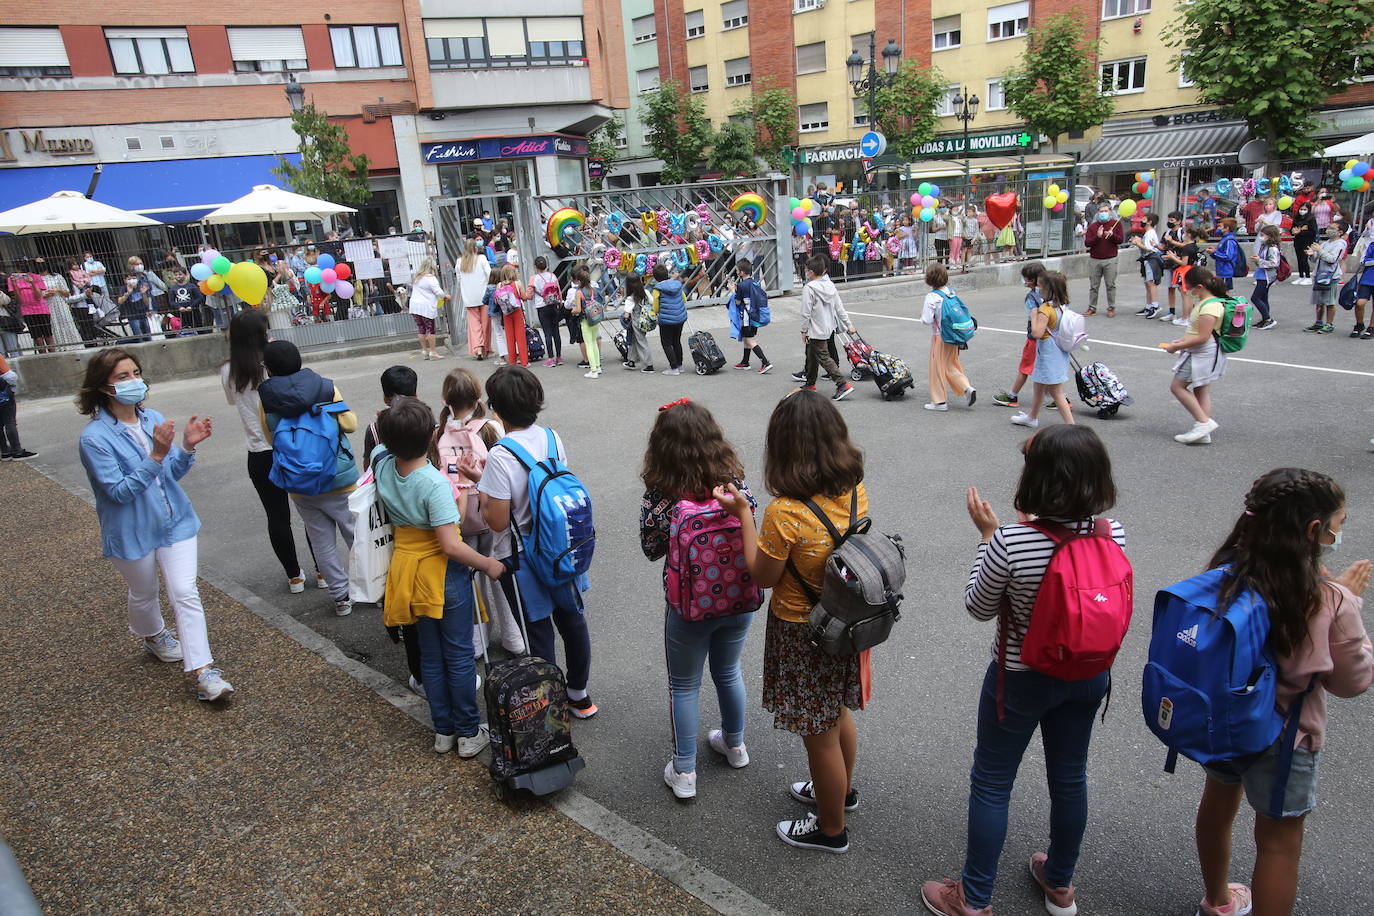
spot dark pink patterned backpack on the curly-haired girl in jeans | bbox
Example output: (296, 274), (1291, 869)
(664, 500), (764, 622)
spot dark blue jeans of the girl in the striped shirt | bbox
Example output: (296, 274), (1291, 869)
(963, 662), (1109, 909)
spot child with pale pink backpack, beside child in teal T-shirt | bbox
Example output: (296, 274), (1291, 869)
(434, 369), (525, 655)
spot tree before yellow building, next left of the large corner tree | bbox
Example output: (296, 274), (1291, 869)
(1002, 12), (1114, 150)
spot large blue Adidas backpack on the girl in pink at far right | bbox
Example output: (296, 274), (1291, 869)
(1140, 566), (1316, 817)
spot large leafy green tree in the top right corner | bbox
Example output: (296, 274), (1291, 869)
(1164, 0), (1374, 159)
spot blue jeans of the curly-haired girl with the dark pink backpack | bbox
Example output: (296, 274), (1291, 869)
(664, 607), (754, 773)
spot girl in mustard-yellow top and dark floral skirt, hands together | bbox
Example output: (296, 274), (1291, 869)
(714, 390), (872, 853)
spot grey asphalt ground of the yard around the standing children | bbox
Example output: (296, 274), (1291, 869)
(19, 273), (1374, 916)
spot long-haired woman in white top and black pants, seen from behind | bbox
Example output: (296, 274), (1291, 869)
(220, 309), (305, 593)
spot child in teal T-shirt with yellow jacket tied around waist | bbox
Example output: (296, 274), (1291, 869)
(371, 397), (506, 757)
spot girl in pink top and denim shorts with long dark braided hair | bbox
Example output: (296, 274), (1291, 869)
(1165, 468), (1374, 916)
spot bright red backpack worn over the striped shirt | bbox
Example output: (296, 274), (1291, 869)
(998, 518), (1135, 715)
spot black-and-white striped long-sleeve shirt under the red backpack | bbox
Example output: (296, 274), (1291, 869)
(963, 518), (1125, 672)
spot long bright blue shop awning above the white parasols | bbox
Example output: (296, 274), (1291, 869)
(0, 152), (300, 222)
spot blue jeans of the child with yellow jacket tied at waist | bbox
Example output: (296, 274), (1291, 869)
(415, 560), (481, 737)
